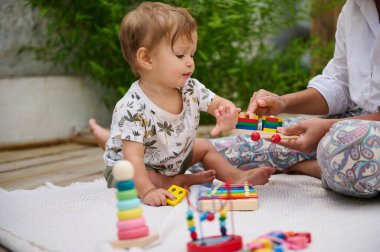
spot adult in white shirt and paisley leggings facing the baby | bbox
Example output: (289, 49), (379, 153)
(248, 0), (380, 197)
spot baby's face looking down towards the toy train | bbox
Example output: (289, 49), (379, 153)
(148, 32), (197, 88)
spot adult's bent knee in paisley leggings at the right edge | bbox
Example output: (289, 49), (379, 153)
(317, 120), (380, 198)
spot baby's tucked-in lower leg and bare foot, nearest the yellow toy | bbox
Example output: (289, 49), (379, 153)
(148, 170), (216, 189)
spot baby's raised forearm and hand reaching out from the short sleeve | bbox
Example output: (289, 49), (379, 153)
(207, 95), (241, 136)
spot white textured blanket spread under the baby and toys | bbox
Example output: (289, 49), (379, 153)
(0, 175), (380, 252)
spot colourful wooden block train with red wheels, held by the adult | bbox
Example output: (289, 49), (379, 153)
(232, 112), (298, 143)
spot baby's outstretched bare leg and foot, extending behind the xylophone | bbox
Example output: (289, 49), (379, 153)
(192, 138), (275, 185)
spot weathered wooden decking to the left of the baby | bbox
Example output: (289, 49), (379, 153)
(0, 126), (217, 190)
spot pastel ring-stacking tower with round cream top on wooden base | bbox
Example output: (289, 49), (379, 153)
(111, 160), (158, 248)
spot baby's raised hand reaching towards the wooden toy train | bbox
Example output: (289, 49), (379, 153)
(210, 106), (241, 136)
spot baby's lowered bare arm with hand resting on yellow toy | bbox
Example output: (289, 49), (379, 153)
(122, 140), (175, 206)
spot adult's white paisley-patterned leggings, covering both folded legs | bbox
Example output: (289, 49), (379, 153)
(190, 110), (380, 198)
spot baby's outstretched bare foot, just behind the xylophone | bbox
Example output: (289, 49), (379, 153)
(232, 166), (276, 185)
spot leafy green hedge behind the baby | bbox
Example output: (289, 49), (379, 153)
(27, 0), (336, 123)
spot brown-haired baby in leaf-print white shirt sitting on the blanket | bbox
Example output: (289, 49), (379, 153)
(104, 2), (274, 206)
